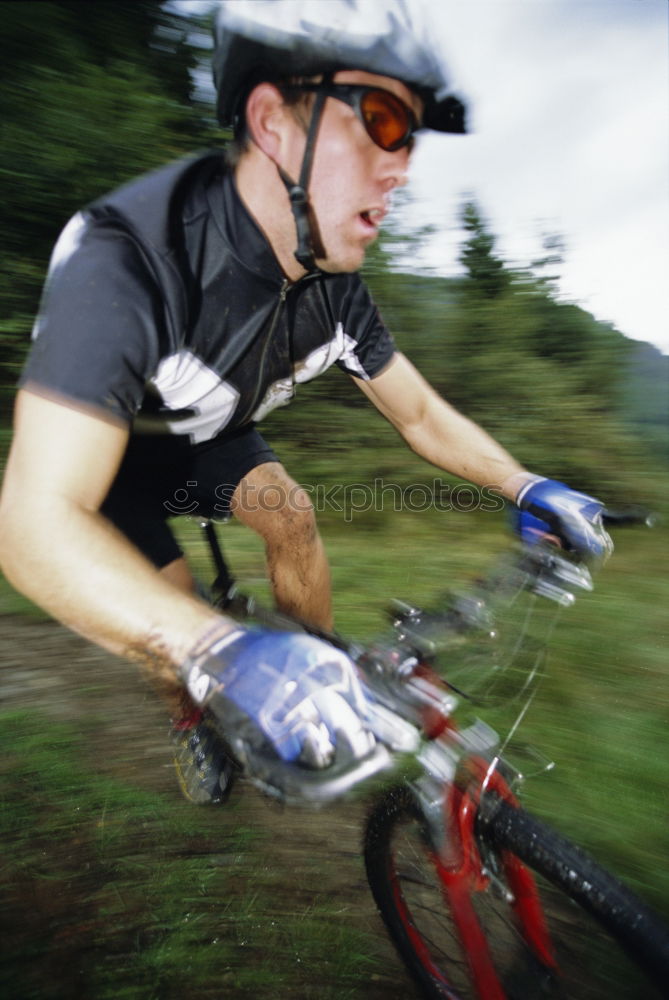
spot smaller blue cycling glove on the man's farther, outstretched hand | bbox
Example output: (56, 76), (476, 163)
(515, 479), (613, 562)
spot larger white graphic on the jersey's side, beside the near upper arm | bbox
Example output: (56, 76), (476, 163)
(140, 349), (239, 444)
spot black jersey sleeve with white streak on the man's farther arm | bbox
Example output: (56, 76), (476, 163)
(330, 274), (396, 381)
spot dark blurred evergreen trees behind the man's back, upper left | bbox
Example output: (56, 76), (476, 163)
(0, 0), (218, 413)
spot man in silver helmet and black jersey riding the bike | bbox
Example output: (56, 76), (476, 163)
(1, 0), (610, 801)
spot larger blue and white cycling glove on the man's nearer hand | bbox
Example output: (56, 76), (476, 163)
(181, 629), (375, 768)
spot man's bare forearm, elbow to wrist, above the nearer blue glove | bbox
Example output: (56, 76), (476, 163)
(0, 497), (232, 689)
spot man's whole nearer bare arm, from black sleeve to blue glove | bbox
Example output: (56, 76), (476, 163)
(0, 390), (230, 690)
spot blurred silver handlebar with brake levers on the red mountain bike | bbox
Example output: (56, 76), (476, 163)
(213, 506), (655, 805)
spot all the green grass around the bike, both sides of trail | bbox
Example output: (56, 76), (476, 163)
(0, 500), (669, 1000)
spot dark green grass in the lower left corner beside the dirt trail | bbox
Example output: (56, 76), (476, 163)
(0, 712), (374, 1000)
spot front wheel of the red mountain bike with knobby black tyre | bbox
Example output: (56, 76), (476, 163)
(364, 786), (669, 1000)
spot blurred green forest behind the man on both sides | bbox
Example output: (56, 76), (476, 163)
(0, 0), (669, 498)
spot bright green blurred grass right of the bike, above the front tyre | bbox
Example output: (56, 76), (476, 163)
(516, 530), (669, 916)
